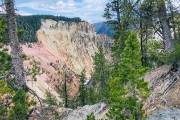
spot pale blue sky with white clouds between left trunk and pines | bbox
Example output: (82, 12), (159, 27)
(15, 0), (108, 23)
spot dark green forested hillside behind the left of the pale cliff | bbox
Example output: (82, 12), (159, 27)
(0, 14), (82, 42)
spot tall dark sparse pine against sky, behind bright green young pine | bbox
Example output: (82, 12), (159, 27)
(103, 0), (140, 66)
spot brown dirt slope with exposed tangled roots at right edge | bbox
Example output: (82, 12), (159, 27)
(144, 65), (180, 116)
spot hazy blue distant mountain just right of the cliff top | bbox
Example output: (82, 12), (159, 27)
(94, 22), (113, 36)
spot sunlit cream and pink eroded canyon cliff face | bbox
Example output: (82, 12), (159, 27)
(23, 20), (112, 101)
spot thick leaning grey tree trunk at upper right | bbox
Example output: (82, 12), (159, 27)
(157, 0), (174, 52)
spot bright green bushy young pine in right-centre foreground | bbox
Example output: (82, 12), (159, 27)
(108, 32), (149, 120)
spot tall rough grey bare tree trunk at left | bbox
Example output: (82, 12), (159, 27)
(5, 0), (26, 88)
